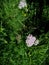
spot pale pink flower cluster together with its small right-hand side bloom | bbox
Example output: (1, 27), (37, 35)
(26, 34), (39, 47)
